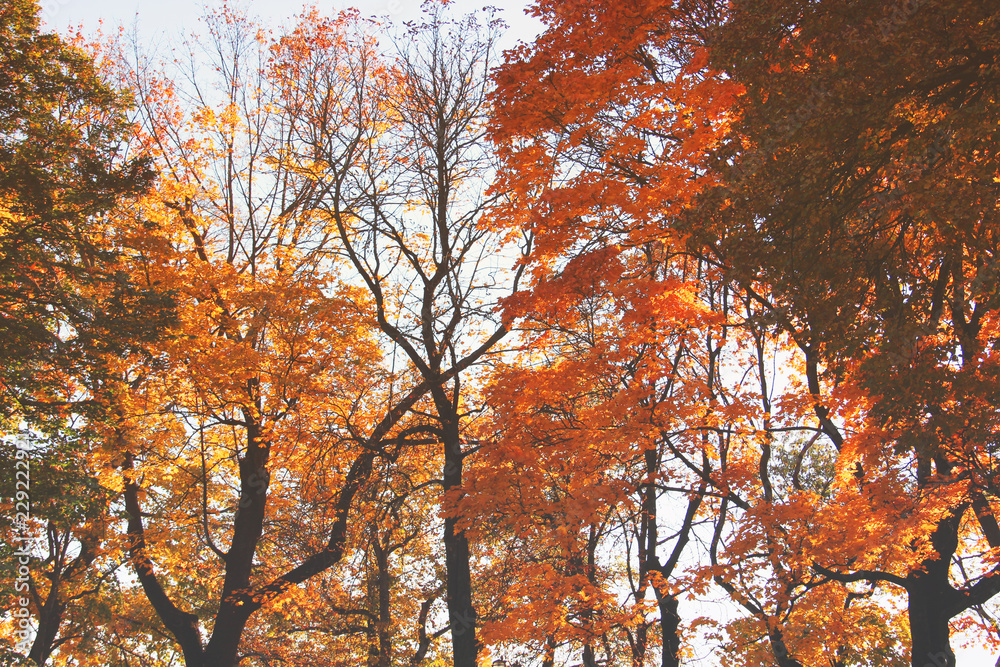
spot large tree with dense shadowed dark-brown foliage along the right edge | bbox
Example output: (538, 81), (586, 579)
(691, 2), (1000, 666)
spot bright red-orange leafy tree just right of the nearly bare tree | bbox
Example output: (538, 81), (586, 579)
(484, 2), (752, 665)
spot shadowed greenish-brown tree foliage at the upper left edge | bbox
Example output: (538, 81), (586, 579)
(0, 0), (158, 424)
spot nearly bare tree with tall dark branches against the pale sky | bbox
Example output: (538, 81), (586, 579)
(280, 9), (521, 666)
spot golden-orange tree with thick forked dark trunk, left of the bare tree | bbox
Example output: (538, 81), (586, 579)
(104, 9), (440, 665)
